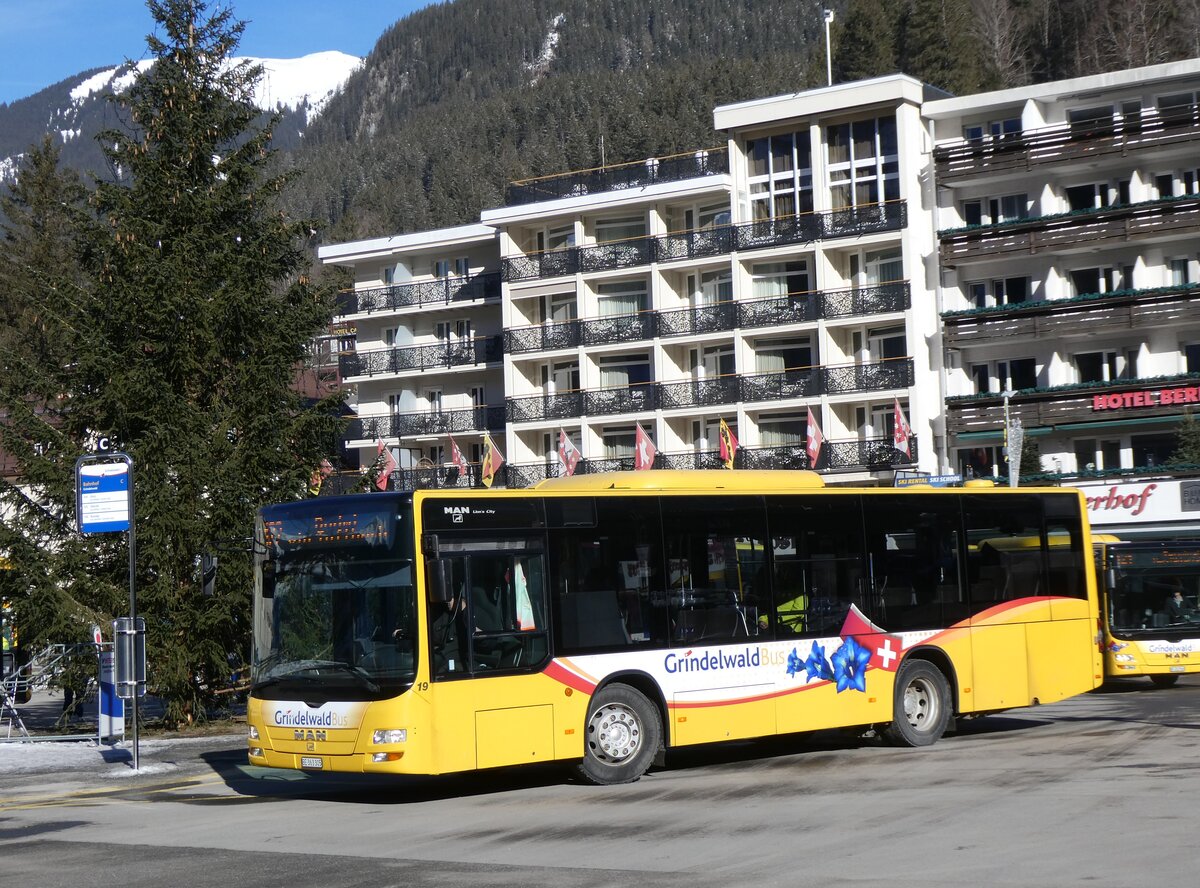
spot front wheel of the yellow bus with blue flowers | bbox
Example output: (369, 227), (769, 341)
(578, 684), (662, 786)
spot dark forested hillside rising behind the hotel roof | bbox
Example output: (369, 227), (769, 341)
(287, 0), (1200, 240)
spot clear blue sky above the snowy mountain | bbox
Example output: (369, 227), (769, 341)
(0, 0), (431, 102)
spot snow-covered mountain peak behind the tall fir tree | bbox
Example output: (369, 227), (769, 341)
(0, 52), (362, 181)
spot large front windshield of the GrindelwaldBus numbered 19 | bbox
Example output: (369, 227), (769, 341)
(253, 496), (416, 700)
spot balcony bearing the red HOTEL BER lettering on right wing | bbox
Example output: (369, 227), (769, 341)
(946, 373), (1200, 434)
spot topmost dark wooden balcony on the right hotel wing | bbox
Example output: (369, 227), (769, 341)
(934, 104), (1200, 185)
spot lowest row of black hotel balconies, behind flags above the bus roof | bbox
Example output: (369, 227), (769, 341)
(502, 438), (918, 487)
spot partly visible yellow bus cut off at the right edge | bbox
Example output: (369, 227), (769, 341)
(1094, 535), (1200, 688)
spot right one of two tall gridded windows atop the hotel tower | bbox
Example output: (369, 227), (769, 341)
(826, 118), (900, 210)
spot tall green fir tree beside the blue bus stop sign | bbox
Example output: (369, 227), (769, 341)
(2, 0), (337, 722)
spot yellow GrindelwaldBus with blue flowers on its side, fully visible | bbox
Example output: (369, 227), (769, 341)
(247, 470), (1103, 784)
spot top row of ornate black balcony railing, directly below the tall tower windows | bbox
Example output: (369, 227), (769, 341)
(500, 200), (908, 282)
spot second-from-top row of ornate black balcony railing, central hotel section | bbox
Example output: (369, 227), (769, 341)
(504, 283), (911, 354)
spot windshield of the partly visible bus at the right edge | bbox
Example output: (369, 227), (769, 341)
(1108, 542), (1200, 637)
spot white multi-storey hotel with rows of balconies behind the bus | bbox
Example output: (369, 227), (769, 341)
(320, 60), (1200, 528)
